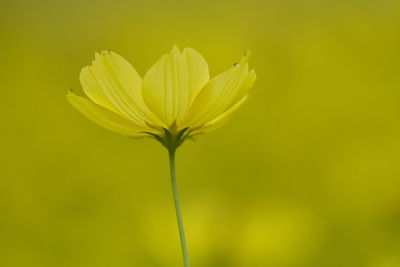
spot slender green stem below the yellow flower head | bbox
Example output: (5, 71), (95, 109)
(168, 148), (190, 267)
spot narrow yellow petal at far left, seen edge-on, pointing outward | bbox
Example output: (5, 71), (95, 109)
(67, 92), (147, 137)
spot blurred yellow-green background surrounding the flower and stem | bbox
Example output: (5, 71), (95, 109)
(0, 0), (400, 267)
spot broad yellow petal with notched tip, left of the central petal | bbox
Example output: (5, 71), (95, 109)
(80, 51), (160, 130)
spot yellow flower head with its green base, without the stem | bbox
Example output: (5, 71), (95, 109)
(67, 46), (256, 150)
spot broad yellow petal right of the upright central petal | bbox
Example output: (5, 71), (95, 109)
(183, 53), (256, 128)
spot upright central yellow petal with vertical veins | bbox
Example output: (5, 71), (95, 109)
(143, 46), (209, 127)
